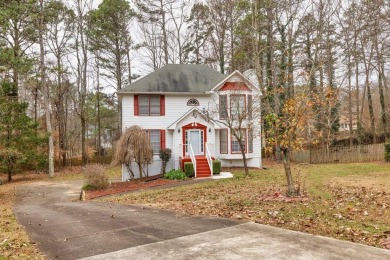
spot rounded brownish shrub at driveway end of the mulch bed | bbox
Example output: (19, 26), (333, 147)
(83, 164), (110, 190)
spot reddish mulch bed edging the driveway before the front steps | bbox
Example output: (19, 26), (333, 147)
(85, 178), (178, 200)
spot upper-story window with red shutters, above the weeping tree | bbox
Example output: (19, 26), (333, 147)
(134, 95), (165, 116)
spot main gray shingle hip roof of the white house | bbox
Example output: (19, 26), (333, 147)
(118, 64), (227, 93)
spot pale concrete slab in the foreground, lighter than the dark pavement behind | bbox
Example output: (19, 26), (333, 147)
(85, 223), (390, 260)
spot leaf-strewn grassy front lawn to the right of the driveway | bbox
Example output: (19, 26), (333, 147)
(103, 163), (390, 248)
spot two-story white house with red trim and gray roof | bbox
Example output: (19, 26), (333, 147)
(118, 64), (261, 181)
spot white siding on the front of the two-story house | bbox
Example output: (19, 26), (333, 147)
(122, 72), (261, 180)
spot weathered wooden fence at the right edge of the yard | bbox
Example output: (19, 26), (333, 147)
(290, 143), (385, 164)
